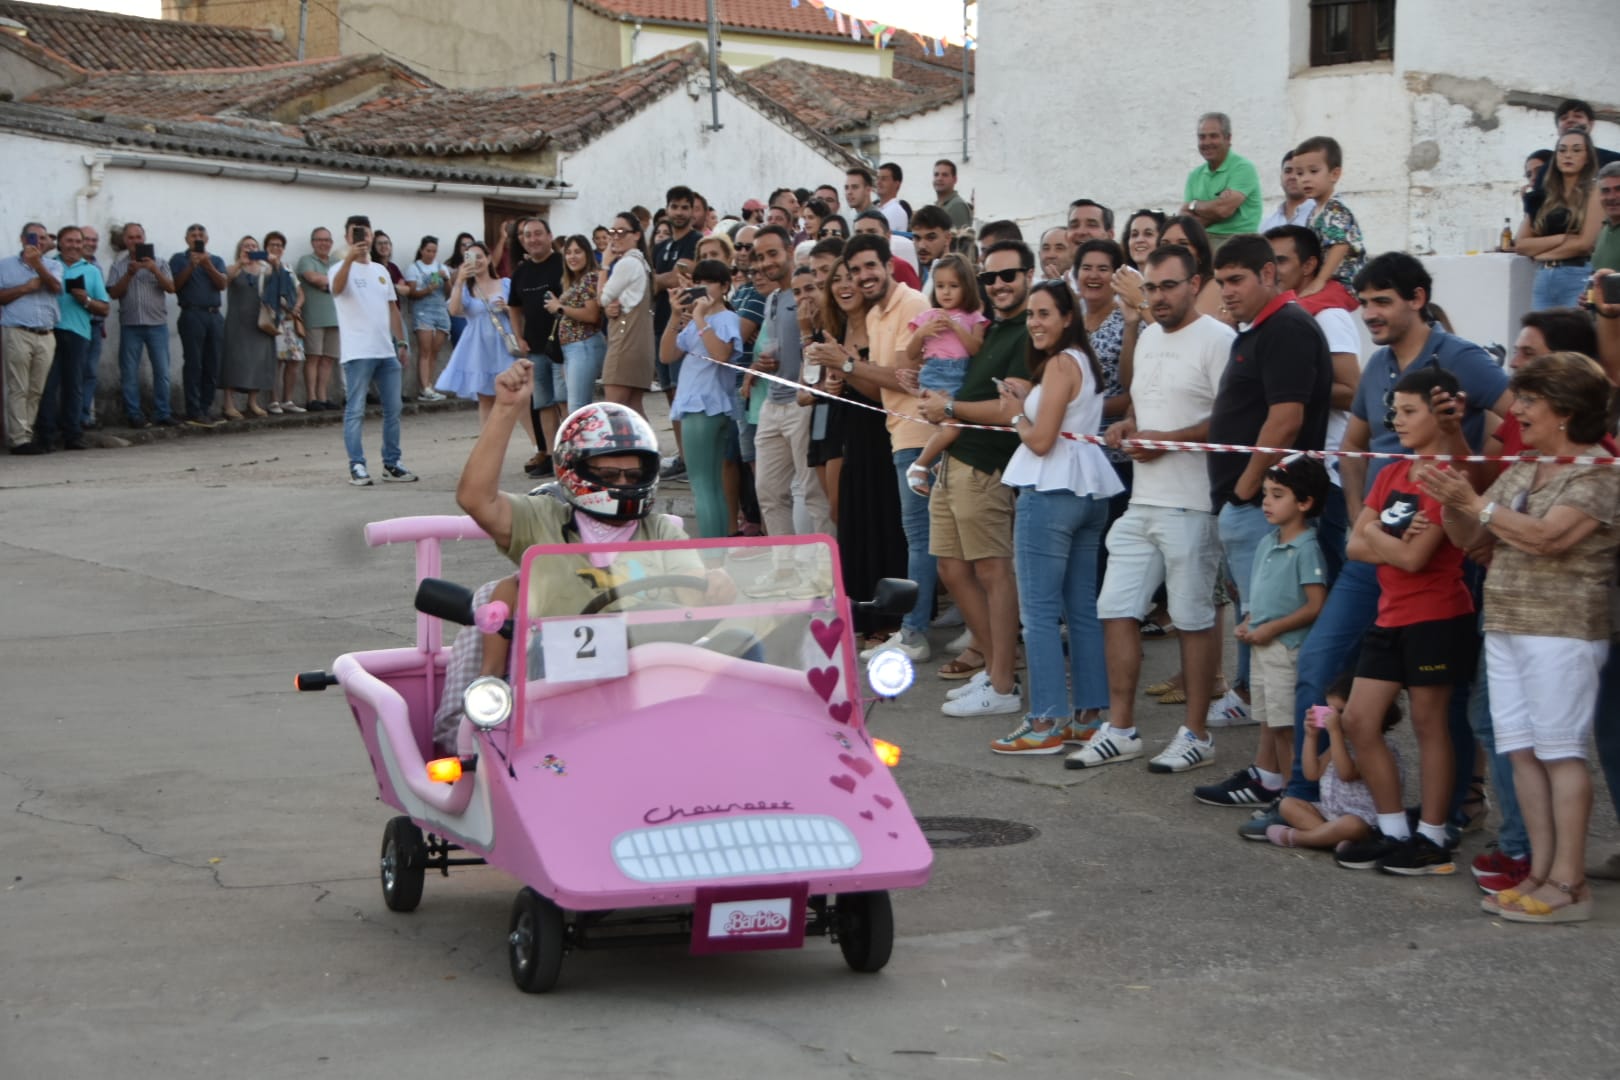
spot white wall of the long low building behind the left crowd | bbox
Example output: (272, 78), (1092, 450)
(0, 133), (505, 415)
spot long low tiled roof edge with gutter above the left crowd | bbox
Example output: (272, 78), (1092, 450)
(0, 100), (567, 189)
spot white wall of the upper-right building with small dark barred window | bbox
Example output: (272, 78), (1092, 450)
(975, 0), (1620, 262)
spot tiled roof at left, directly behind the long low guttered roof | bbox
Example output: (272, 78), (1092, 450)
(28, 55), (433, 120)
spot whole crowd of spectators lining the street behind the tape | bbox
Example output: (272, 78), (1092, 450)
(9, 102), (1620, 921)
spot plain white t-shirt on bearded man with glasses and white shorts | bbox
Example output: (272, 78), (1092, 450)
(1131, 316), (1238, 512)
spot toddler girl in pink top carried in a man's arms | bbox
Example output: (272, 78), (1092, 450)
(897, 253), (990, 495)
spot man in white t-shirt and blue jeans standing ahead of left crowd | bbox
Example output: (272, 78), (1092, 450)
(332, 214), (416, 487)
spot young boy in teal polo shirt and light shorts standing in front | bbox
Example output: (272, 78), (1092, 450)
(1192, 453), (1332, 806)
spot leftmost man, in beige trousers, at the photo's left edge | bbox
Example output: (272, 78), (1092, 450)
(0, 222), (62, 453)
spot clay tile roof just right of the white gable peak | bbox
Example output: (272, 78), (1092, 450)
(740, 57), (962, 134)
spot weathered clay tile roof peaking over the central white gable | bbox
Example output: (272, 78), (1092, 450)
(305, 44), (846, 160)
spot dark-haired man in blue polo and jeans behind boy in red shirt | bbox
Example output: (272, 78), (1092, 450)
(1263, 251), (1511, 836)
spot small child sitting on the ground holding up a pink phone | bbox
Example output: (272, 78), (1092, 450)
(1265, 674), (1405, 848)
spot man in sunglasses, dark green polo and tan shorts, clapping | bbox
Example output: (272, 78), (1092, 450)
(919, 240), (1035, 716)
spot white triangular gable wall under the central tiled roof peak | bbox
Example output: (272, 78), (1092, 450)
(551, 79), (844, 233)
